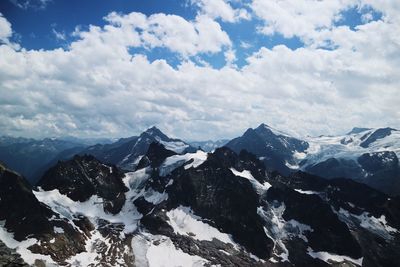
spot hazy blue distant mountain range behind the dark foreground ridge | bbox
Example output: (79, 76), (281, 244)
(0, 124), (400, 198)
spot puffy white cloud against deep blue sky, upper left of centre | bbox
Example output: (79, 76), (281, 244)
(101, 12), (231, 57)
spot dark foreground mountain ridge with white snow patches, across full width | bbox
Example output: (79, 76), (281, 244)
(0, 142), (400, 267)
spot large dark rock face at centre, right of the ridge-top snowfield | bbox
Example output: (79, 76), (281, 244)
(167, 148), (273, 259)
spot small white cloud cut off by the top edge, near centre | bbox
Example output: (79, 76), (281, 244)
(191, 0), (251, 23)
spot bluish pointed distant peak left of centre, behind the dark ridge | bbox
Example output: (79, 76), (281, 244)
(80, 127), (195, 171)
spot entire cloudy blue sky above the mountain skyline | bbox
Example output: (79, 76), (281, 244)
(0, 0), (400, 140)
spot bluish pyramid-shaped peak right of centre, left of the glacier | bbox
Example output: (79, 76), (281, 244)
(225, 124), (309, 174)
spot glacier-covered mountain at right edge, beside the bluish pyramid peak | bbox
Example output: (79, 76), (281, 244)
(298, 128), (400, 195)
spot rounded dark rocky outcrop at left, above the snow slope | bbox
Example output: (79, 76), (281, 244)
(38, 155), (128, 214)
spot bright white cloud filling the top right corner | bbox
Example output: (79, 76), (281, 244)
(250, 0), (400, 45)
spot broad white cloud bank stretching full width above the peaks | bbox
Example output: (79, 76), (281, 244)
(0, 3), (400, 139)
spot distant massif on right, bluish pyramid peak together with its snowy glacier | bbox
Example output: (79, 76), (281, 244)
(226, 124), (400, 195)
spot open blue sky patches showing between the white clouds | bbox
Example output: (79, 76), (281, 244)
(0, 0), (380, 68)
